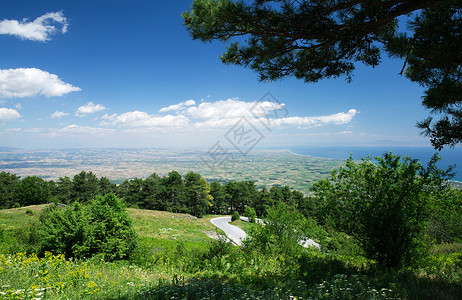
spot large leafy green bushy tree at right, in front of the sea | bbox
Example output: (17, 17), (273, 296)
(313, 153), (450, 268)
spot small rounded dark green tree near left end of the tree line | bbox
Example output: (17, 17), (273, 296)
(13, 176), (51, 206)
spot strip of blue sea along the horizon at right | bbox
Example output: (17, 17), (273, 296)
(290, 147), (462, 181)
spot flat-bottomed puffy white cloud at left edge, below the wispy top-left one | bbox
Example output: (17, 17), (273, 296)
(0, 68), (81, 98)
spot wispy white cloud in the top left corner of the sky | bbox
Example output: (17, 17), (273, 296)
(0, 12), (69, 42)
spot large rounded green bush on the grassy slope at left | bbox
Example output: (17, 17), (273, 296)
(32, 194), (136, 261)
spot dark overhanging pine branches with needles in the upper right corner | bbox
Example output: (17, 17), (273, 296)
(182, 0), (462, 148)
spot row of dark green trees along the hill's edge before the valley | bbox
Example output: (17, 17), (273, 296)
(0, 171), (315, 217)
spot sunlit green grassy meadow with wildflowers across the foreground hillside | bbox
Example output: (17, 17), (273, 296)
(0, 205), (462, 299)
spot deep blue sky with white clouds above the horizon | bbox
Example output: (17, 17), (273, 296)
(0, 0), (430, 148)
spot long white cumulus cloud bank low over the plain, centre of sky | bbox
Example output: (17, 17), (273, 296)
(101, 99), (358, 129)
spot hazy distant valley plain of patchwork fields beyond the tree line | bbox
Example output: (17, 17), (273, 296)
(0, 148), (344, 193)
